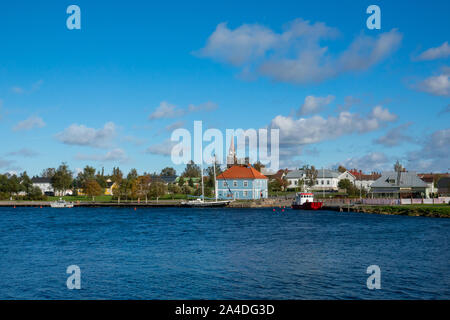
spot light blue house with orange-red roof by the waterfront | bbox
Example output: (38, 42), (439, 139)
(216, 165), (269, 200)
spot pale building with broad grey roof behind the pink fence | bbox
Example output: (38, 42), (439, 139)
(370, 171), (429, 198)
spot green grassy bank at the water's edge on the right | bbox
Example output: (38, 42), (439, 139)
(358, 204), (450, 218)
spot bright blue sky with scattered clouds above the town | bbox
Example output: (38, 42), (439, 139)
(0, 0), (450, 174)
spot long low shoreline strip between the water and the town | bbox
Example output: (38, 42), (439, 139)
(0, 199), (450, 218)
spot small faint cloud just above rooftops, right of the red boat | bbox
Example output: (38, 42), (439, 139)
(335, 152), (392, 172)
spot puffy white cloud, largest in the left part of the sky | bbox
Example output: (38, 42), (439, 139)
(56, 122), (116, 148)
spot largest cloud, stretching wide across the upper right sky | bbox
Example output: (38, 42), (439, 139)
(198, 19), (402, 83)
